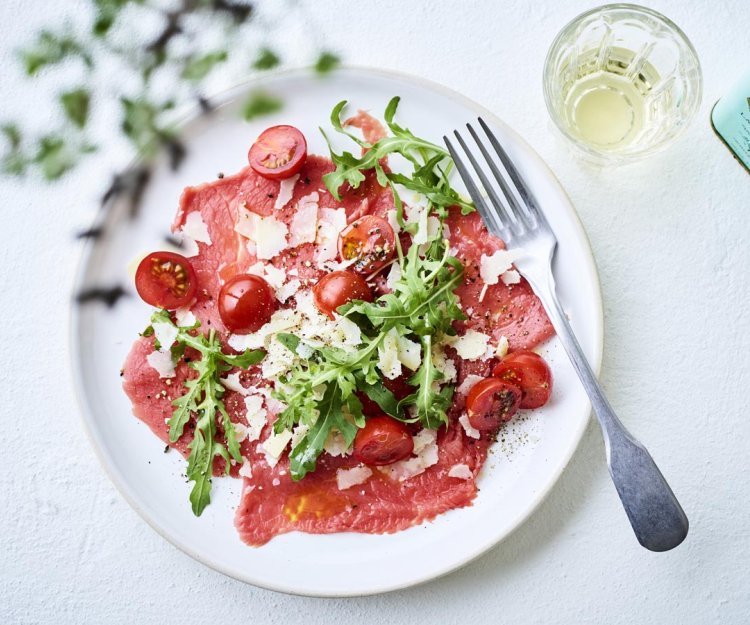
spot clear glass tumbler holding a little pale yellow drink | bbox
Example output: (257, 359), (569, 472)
(544, 4), (703, 163)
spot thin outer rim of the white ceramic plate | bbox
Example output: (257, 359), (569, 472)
(67, 64), (604, 598)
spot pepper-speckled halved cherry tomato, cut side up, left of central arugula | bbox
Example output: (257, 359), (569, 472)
(339, 215), (396, 275)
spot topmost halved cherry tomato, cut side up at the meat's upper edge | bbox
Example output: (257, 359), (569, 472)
(247, 126), (307, 180)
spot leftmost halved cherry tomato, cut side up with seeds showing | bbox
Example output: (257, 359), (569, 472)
(135, 252), (198, 310)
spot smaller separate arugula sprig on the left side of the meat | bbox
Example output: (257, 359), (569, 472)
(143, 310), (265, 516)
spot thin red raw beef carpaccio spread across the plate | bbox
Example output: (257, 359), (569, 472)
(123, 145), (552, 545)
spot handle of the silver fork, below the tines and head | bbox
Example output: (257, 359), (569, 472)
(533, 272), (688, 551)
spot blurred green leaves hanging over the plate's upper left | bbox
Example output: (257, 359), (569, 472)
(0, 0), (339, 180)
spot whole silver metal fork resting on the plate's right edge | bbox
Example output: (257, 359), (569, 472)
(450, 118), (688, 551)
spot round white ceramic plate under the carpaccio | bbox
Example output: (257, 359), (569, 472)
(72, 68), (602, 596)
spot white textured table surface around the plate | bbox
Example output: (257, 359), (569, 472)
(0, 0), (750, 625)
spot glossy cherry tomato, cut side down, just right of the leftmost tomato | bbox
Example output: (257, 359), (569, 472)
(219, 273), (276, 334)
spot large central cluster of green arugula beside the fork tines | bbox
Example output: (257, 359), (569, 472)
(274, 97), (474, 480)
